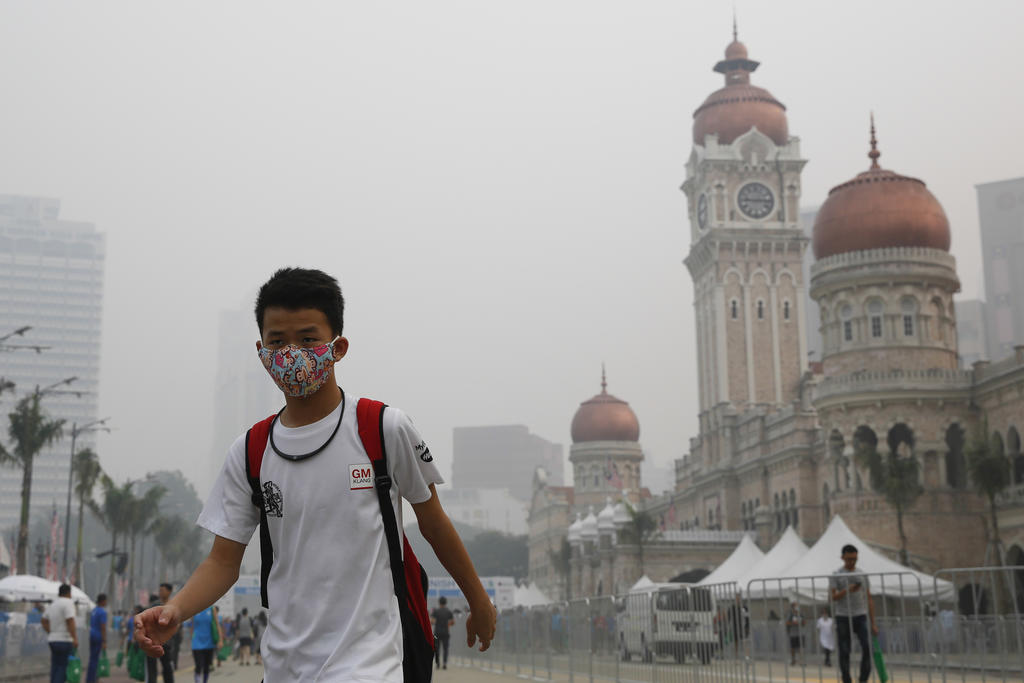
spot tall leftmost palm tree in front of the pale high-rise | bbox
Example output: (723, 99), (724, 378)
(0, 391), (65, 572)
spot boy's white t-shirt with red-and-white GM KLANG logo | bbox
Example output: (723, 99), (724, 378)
(198, 396), (443, 683)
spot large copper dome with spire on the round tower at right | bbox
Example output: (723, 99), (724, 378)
(812, 121), (950, 259)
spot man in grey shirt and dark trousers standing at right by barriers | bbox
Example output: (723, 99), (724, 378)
(828, 544), (879, 683)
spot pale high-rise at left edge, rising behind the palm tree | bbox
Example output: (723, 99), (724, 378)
(0, 195), (105, 531)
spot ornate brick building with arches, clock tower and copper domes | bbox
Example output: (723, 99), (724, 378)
(530, 29), (1024, 596)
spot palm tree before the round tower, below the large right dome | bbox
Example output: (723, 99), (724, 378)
(854, 425), (925, 566)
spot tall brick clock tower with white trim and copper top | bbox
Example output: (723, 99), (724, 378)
(682, 31), (808, 460)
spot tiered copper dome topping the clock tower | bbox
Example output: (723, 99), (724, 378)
(693, 40), (790, 144)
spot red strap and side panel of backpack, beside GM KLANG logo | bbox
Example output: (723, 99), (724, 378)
(355, 398), (434, 655)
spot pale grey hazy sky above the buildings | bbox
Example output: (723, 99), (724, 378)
(0, 0), (1024, 499)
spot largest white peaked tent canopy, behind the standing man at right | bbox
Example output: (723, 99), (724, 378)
(750, 515), (956, 602)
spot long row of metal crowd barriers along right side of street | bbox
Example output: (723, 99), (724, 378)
(452, 567), (1024, 683)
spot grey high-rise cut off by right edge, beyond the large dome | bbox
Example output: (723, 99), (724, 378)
(977, 178), (1024, 362)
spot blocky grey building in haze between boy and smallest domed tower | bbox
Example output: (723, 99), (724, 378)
(452, 425), (562, 501)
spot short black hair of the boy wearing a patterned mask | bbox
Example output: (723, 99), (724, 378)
(256, 268), (345, 336)
